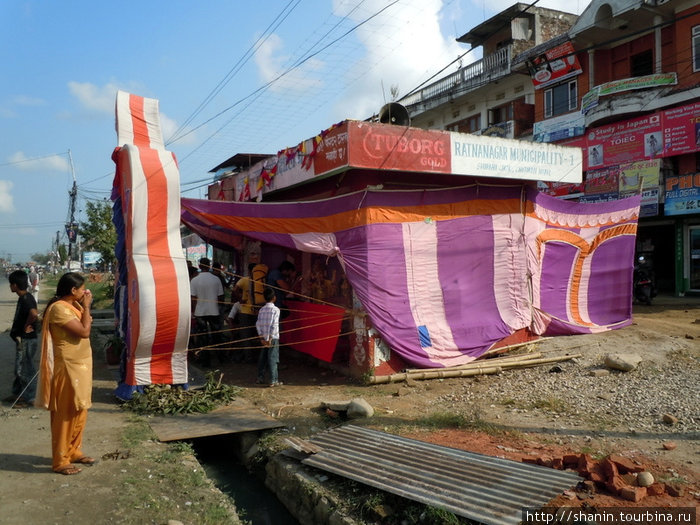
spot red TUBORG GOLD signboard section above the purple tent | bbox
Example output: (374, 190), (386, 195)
(348, 122), (452, 173)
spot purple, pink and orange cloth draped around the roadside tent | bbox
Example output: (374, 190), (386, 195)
(182, 184), (640, 367)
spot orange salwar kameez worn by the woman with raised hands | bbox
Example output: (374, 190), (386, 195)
(36, 301), (92, 471)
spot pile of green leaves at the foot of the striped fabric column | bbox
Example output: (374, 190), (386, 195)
(122, 371), (241, 415)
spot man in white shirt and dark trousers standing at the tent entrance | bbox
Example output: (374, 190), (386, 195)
(190, 257), (224, 366)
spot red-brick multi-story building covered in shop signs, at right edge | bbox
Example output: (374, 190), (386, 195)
(514, 0), (700, 295)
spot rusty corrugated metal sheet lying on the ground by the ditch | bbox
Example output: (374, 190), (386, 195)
(303, 425), (581, 524)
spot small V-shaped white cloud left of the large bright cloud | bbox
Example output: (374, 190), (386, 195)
(255, 34), (323, 93)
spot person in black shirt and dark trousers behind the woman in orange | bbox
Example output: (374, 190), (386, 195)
(5, 270), (39, 408)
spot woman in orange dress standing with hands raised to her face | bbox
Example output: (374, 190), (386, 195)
(35, 272), (95, 475)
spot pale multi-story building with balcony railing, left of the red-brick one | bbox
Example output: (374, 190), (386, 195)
(399, 3), (577, 138)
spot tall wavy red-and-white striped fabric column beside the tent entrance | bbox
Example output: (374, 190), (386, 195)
(114, 91), (190, 385)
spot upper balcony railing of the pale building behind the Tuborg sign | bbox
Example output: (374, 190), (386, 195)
(399, 46), (512, 113)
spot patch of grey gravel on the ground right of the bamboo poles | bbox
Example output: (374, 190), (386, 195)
(435, 354), (700, 434)
